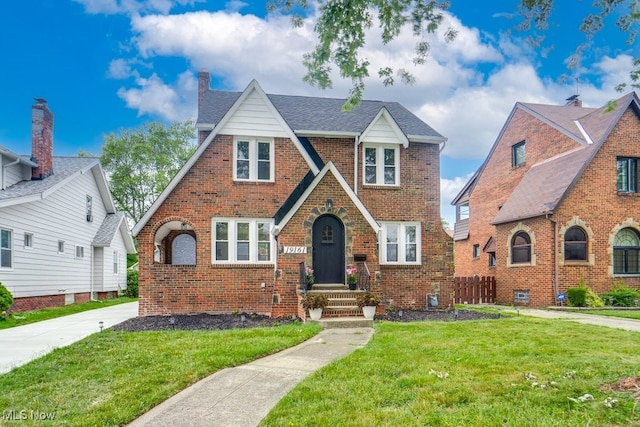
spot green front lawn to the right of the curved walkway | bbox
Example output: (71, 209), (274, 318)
(261, 317), (640, 427)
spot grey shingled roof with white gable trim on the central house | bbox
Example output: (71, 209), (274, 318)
(133, 80), (446, 235)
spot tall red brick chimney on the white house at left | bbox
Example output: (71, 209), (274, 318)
(31, 98), (53, 179)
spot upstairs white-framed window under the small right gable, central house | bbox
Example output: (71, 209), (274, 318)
(362, 144), (400, 185)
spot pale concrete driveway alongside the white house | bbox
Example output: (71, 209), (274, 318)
(0, 302), (138, 374)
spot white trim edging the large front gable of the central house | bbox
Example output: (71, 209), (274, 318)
(133, 80), (320, 236)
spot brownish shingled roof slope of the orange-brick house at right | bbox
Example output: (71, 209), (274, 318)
(491, 92), (640, 225)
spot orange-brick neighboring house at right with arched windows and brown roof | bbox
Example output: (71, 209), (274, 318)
(452, 93), (640, 306)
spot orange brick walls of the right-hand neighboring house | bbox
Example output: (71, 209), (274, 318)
(455, 96), (640, 306)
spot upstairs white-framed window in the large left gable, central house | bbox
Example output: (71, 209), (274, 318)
(233, 138), (274, 181)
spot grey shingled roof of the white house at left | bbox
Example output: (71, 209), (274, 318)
(0, 157), (116, 213)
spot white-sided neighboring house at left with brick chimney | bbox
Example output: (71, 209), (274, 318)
(0, 99), (135, 311)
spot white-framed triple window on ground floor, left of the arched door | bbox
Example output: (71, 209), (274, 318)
(211, 218), (276, 264)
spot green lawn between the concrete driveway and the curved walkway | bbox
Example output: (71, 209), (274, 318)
(0, 323), (319, 426)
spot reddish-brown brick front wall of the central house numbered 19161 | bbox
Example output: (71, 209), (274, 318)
(138, 110), (453, 317)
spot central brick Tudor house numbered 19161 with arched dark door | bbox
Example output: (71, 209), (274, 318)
(133, 70), (453, 318)
